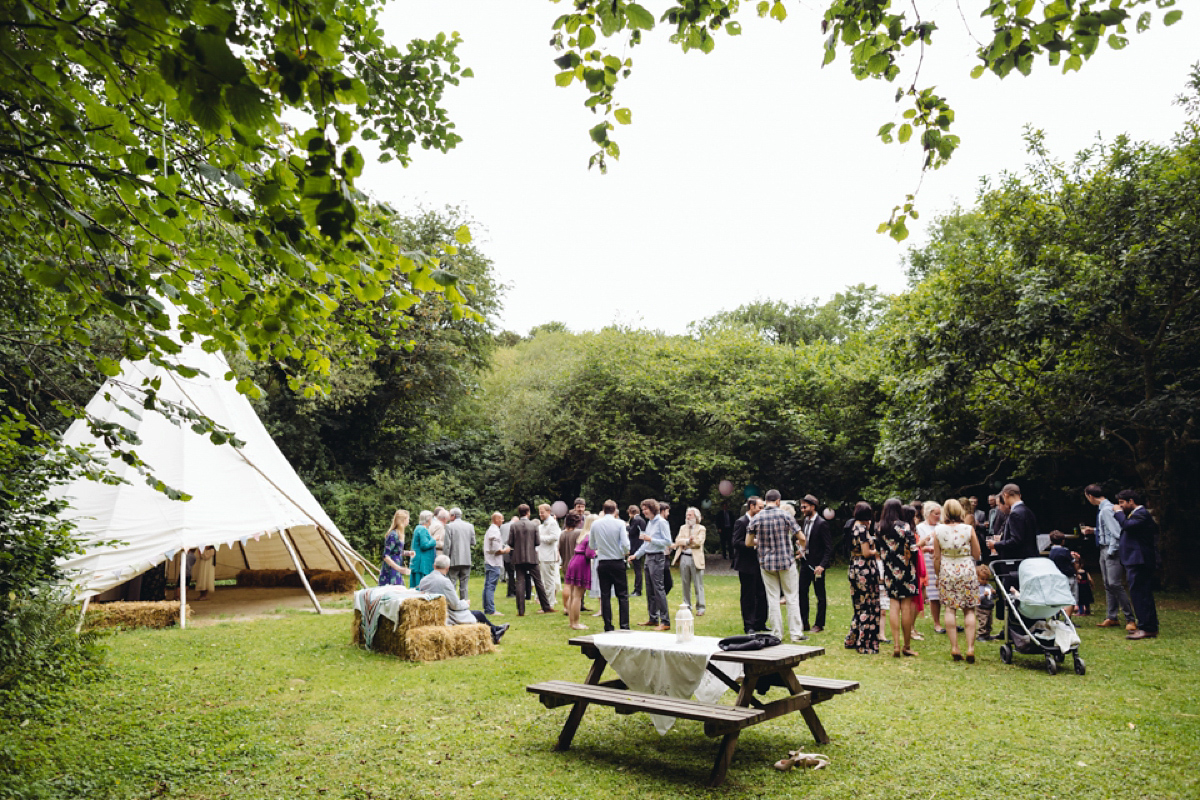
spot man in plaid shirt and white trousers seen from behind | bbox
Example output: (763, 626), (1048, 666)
(746, 489), (805, 642)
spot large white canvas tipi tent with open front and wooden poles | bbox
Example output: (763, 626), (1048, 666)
(54, 331), (373, 624)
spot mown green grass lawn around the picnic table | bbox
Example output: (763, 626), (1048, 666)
(0, 570), (1200, 800)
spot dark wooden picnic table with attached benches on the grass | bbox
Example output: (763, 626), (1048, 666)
(526, 633), (858, 786)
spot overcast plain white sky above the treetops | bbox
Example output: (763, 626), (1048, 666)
(360, 0), (1200, 333)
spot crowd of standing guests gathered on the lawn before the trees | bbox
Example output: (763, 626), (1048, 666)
(379, 483), (1158, 647)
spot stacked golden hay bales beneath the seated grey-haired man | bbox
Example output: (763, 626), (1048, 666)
(353, 597), (496, 661)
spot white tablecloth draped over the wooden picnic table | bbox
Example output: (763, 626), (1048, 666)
(592, 631), (742, 735)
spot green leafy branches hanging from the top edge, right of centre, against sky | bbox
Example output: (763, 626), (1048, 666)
(551, 0), (1183, 241)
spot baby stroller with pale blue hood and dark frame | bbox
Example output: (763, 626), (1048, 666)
(990, 558), (1087, 675)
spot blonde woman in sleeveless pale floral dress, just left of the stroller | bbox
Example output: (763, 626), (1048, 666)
(934, 499), (979, 663)
